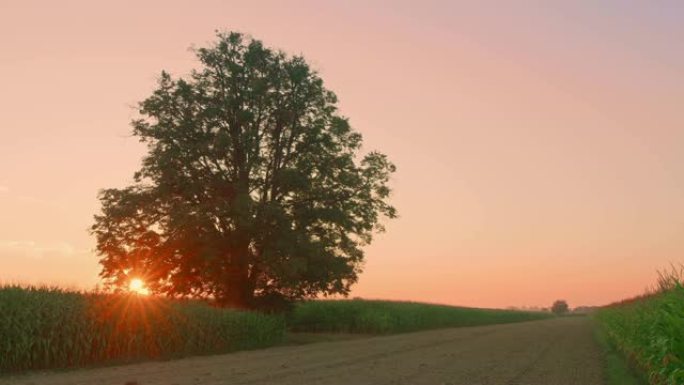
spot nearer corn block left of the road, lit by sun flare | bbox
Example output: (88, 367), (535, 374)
(0, 286), (285, 373)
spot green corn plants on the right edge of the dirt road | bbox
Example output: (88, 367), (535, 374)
(595, 269), (684, 385)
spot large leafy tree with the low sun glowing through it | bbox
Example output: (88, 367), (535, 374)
(92, 33), (396, 307)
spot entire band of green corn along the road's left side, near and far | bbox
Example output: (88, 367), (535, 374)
(0, 286), (552, 373)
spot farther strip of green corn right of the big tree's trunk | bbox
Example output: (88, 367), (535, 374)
(288, 300), (552, 334)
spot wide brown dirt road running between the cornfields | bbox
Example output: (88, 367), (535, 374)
(0, 317), (603, 385)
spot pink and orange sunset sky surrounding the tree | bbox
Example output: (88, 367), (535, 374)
(0, 0), (684, 307)
